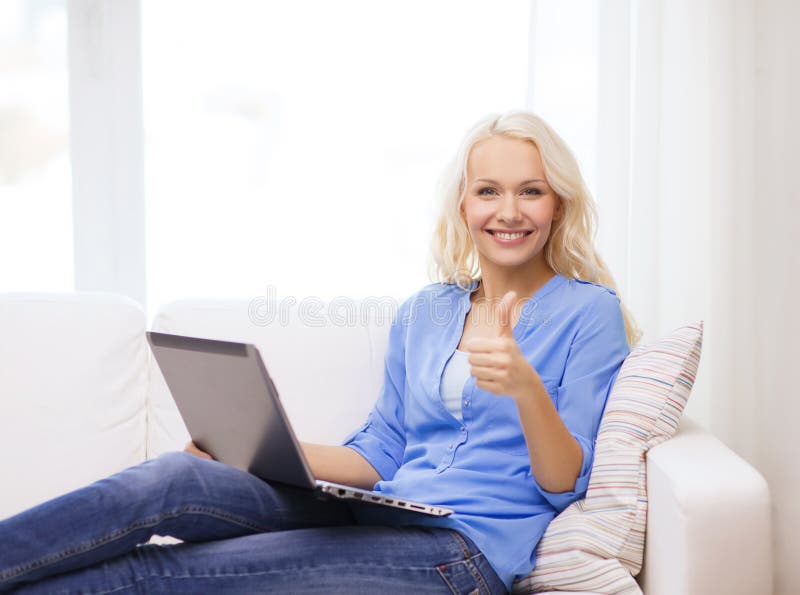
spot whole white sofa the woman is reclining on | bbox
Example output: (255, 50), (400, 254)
(0, 292), (772, 595)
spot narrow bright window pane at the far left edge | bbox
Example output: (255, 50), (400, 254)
(0, 0), (74, 291)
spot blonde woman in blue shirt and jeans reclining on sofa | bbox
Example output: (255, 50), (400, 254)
(0, 112), (638, 594)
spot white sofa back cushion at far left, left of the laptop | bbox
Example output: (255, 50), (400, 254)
(0, 292), (148, 519)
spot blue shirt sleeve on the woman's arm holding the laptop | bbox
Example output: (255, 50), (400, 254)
(342, 298), (411, 480)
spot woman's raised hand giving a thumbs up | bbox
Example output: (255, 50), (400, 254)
(464, 291), (539, 400)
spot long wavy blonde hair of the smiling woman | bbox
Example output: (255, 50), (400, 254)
(428, 110), (642, 347)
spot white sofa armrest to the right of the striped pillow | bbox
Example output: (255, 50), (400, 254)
(638, 416), (772, 595)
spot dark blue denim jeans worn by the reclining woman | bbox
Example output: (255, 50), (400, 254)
(0, 452), (506, 595)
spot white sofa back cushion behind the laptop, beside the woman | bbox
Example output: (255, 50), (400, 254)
(147, 299), (397, 458)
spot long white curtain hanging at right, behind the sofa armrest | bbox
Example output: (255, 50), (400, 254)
(530, 0), (800, 595)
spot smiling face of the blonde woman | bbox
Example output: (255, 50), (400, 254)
(462, 135), (562, 273)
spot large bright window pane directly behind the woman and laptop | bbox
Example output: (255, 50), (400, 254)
(142, 0), (530, 312)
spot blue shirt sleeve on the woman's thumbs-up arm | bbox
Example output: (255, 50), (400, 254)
(536, 291), (630, 513)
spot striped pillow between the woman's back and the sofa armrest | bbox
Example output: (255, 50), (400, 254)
(512, 321), (703, 595)
